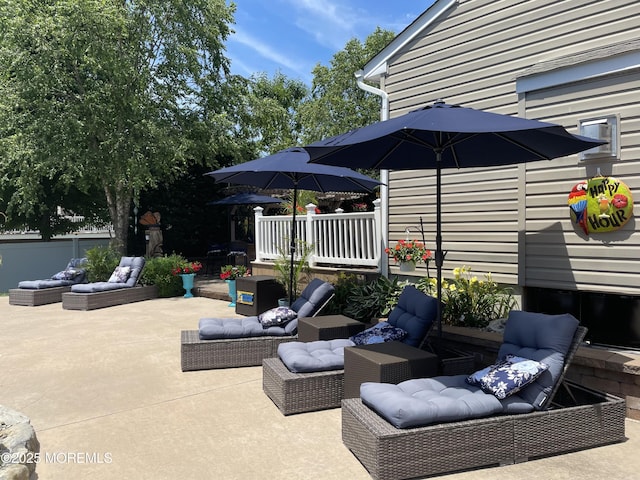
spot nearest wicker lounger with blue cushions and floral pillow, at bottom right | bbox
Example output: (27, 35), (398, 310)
(342, 311), (625, 480)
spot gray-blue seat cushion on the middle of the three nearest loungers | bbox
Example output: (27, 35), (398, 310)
(278, 339), (354, 373)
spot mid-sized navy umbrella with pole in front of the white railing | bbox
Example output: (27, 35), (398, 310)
(205, 147), (380, 304)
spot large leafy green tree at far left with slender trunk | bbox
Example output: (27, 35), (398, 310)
(0, 0), (242, 252)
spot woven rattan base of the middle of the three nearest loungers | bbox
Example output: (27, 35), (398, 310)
(262, 357), (344, 415)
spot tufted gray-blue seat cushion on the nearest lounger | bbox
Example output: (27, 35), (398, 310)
(360, 375), (504, 428)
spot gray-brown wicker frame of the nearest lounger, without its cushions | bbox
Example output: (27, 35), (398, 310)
(342, 312), (625, 480)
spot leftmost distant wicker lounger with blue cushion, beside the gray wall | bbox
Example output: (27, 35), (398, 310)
(9, 258), (87, 307)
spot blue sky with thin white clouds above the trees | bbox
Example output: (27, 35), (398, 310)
(226, 0), (434, 84)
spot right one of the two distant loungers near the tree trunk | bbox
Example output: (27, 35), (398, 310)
(62, 257), (158, 310)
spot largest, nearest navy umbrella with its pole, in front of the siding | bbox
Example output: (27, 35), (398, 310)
(305, 101), (606, 335)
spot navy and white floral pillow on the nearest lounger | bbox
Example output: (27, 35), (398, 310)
(467, 355), (549, 400)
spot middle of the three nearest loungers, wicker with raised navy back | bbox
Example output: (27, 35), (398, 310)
(262, 285), (438, 415)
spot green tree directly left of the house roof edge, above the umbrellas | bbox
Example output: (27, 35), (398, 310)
(299, 27), (395, 144)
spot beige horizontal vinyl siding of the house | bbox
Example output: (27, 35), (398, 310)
(376, 0), (640, 294)
